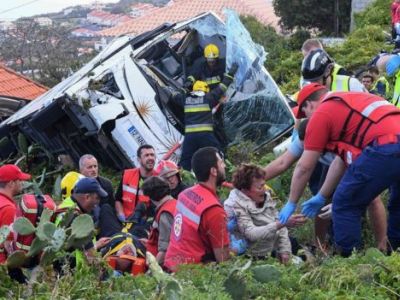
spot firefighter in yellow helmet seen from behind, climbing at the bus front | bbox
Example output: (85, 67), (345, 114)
(169, 64), (238, 171)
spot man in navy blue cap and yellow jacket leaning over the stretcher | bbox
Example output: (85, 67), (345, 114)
(54, 177), (109, 266)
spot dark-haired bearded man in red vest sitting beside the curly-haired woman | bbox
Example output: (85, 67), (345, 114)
(164, 147), (229, 272)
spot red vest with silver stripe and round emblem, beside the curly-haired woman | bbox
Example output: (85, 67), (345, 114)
(164, 184), (221, 271)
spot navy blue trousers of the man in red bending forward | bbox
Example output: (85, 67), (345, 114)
(332, 142), (400, 256)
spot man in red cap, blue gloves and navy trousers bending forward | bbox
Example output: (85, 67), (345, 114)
(280, 84), (400, 256)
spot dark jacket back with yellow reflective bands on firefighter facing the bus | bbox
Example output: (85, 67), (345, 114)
(184, 95), (214, 133)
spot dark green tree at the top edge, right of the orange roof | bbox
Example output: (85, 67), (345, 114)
(273, 0), (351, 36)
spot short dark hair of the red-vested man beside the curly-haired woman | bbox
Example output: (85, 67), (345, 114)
(192, 147), (219, 182)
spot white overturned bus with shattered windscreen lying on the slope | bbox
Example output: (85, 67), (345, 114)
(0, 11), (294, 169)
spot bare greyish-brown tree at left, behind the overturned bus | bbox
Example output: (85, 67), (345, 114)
(0, 19), (91, 86)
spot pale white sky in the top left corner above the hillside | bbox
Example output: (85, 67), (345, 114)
(0, 0), (118, 21)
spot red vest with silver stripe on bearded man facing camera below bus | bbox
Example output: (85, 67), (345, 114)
(122, 168), (150, 217)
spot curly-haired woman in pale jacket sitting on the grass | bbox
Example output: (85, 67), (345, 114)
(229, 164), (306, 263)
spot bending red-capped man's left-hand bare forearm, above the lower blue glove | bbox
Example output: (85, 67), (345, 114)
(289, 150), (321, 203)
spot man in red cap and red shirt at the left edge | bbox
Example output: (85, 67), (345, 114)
(0, 164), (31, 264)
